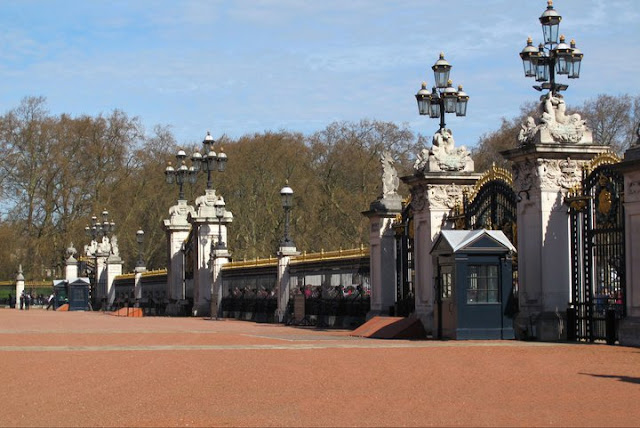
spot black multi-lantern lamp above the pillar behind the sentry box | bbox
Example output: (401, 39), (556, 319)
(416, 53), (469, 129)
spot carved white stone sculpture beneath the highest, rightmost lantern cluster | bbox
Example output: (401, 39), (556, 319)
(518, 92), (592, 145)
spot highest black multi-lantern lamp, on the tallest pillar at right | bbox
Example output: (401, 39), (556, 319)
(520, 0), (584, 94)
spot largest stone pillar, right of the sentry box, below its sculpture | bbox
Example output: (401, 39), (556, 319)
(501, 143), (609, 341)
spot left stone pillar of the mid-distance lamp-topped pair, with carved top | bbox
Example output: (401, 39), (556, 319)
(163, 200), (195, 300)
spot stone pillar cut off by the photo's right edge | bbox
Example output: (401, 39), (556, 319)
(618, 145), (640, 346)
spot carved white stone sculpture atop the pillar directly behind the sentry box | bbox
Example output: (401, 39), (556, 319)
(413, 128), (474, 172)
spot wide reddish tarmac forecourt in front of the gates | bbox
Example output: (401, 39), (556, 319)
(0, 309), (640, 426)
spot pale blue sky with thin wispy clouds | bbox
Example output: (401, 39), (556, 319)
(0, 0), (640, 146)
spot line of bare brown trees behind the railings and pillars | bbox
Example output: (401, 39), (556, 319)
(0, 95), (640, 279)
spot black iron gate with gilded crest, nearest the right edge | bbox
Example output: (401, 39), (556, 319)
(566, 153), (626, 344)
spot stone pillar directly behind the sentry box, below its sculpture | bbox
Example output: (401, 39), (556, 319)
(402, 172), (480, 334)
